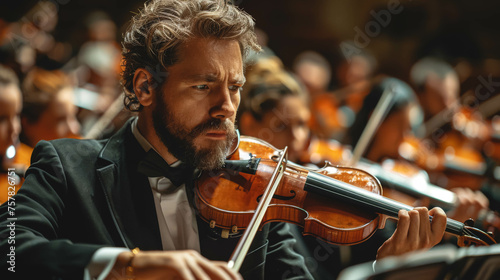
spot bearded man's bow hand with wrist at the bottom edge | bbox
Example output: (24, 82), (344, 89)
(106, 250), (242, 280)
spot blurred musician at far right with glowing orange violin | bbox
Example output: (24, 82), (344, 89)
(405, 57), (488, 190)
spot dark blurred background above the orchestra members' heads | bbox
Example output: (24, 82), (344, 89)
(0, 0), (500, 82)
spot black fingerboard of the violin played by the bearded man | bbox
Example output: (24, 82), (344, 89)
(304, 172), (464, 236)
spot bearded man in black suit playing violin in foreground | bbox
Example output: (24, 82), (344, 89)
(0, 0), (445, 279)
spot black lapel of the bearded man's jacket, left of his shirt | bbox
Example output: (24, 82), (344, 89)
(96, 121), (162, 250)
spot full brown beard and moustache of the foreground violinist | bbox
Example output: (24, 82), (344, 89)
(153, 95), (237, 170)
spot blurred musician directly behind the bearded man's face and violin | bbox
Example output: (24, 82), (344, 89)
(238, 57), (454, 279)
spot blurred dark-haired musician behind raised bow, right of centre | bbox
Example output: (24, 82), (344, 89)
(346, 78), (489, 272)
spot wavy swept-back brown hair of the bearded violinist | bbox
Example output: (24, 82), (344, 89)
(122, 0), (260, 111)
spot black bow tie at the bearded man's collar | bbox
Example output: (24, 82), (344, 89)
(137, 149), (194, 187)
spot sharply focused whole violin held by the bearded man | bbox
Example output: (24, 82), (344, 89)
(195, 137), (495, 270)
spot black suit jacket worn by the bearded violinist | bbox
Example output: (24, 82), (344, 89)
(0, 122), (310, 279)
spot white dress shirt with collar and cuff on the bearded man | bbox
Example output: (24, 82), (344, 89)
(84, 119), (200, 280)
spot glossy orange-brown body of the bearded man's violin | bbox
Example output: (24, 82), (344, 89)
(196, 136), (382, 245)
